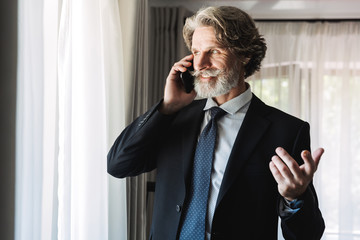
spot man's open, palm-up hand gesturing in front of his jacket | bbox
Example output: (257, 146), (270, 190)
(270, 147), (324, 201)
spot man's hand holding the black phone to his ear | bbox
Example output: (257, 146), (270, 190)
(159, 54), (196, 114)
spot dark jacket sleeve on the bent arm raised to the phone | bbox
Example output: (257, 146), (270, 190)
(107, 103), (174, 178)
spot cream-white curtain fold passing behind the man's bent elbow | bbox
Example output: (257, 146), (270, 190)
(100, 0), (126, 240)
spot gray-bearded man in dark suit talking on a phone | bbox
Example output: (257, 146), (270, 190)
(108, 7), (324, 240)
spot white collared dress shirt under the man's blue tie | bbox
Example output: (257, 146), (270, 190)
(201, 86), (252, 239)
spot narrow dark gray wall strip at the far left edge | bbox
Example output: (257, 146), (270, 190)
(0, 0), (17, 240)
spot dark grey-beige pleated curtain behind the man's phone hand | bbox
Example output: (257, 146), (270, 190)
(127, 4), (191, 240)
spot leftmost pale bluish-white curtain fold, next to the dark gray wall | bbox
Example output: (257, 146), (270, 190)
(15, 0), (44, 239)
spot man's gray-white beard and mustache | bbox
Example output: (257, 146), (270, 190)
(194, 67), (240, 98)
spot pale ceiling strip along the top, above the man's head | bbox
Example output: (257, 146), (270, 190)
(149, 0), (360, 20)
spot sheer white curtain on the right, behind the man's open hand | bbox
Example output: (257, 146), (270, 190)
(250, 22), (360, 240)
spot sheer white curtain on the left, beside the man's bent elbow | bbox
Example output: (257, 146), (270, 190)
(15, 0), (126, 240)
